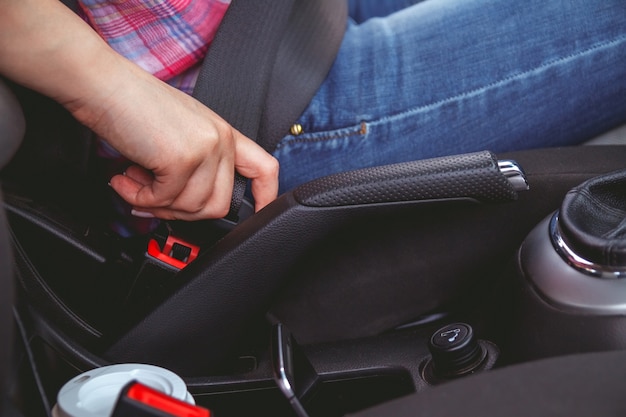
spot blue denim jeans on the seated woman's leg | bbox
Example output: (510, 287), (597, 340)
(274, 0), (626, 192)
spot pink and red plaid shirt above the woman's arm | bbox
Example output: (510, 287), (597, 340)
(80, 0), (230, 93)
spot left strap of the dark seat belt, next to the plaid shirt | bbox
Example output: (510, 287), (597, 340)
(193, 0), (294, 219)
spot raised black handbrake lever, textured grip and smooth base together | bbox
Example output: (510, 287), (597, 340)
(106, 152), (517, 375)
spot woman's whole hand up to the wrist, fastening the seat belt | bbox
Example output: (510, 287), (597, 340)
(74, 63), (278, 220)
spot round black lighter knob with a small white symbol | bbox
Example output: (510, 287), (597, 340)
(428, 323), (486, 377)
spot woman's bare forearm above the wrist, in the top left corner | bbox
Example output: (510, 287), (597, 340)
(0, 0), (138, 124)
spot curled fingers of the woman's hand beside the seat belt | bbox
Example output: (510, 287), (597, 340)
(110, 129), (278, 221)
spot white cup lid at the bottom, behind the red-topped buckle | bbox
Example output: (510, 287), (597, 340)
(52, 363), (195, 417)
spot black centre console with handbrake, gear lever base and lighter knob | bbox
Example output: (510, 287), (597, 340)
(7, 147), (626, 417)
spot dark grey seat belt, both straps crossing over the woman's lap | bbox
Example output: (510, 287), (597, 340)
(193, 0), (348, 219)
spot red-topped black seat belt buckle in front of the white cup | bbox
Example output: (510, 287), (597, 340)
(111, 380), (212, 417)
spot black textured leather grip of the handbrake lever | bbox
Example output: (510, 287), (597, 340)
(294, 151), (517, 207)
